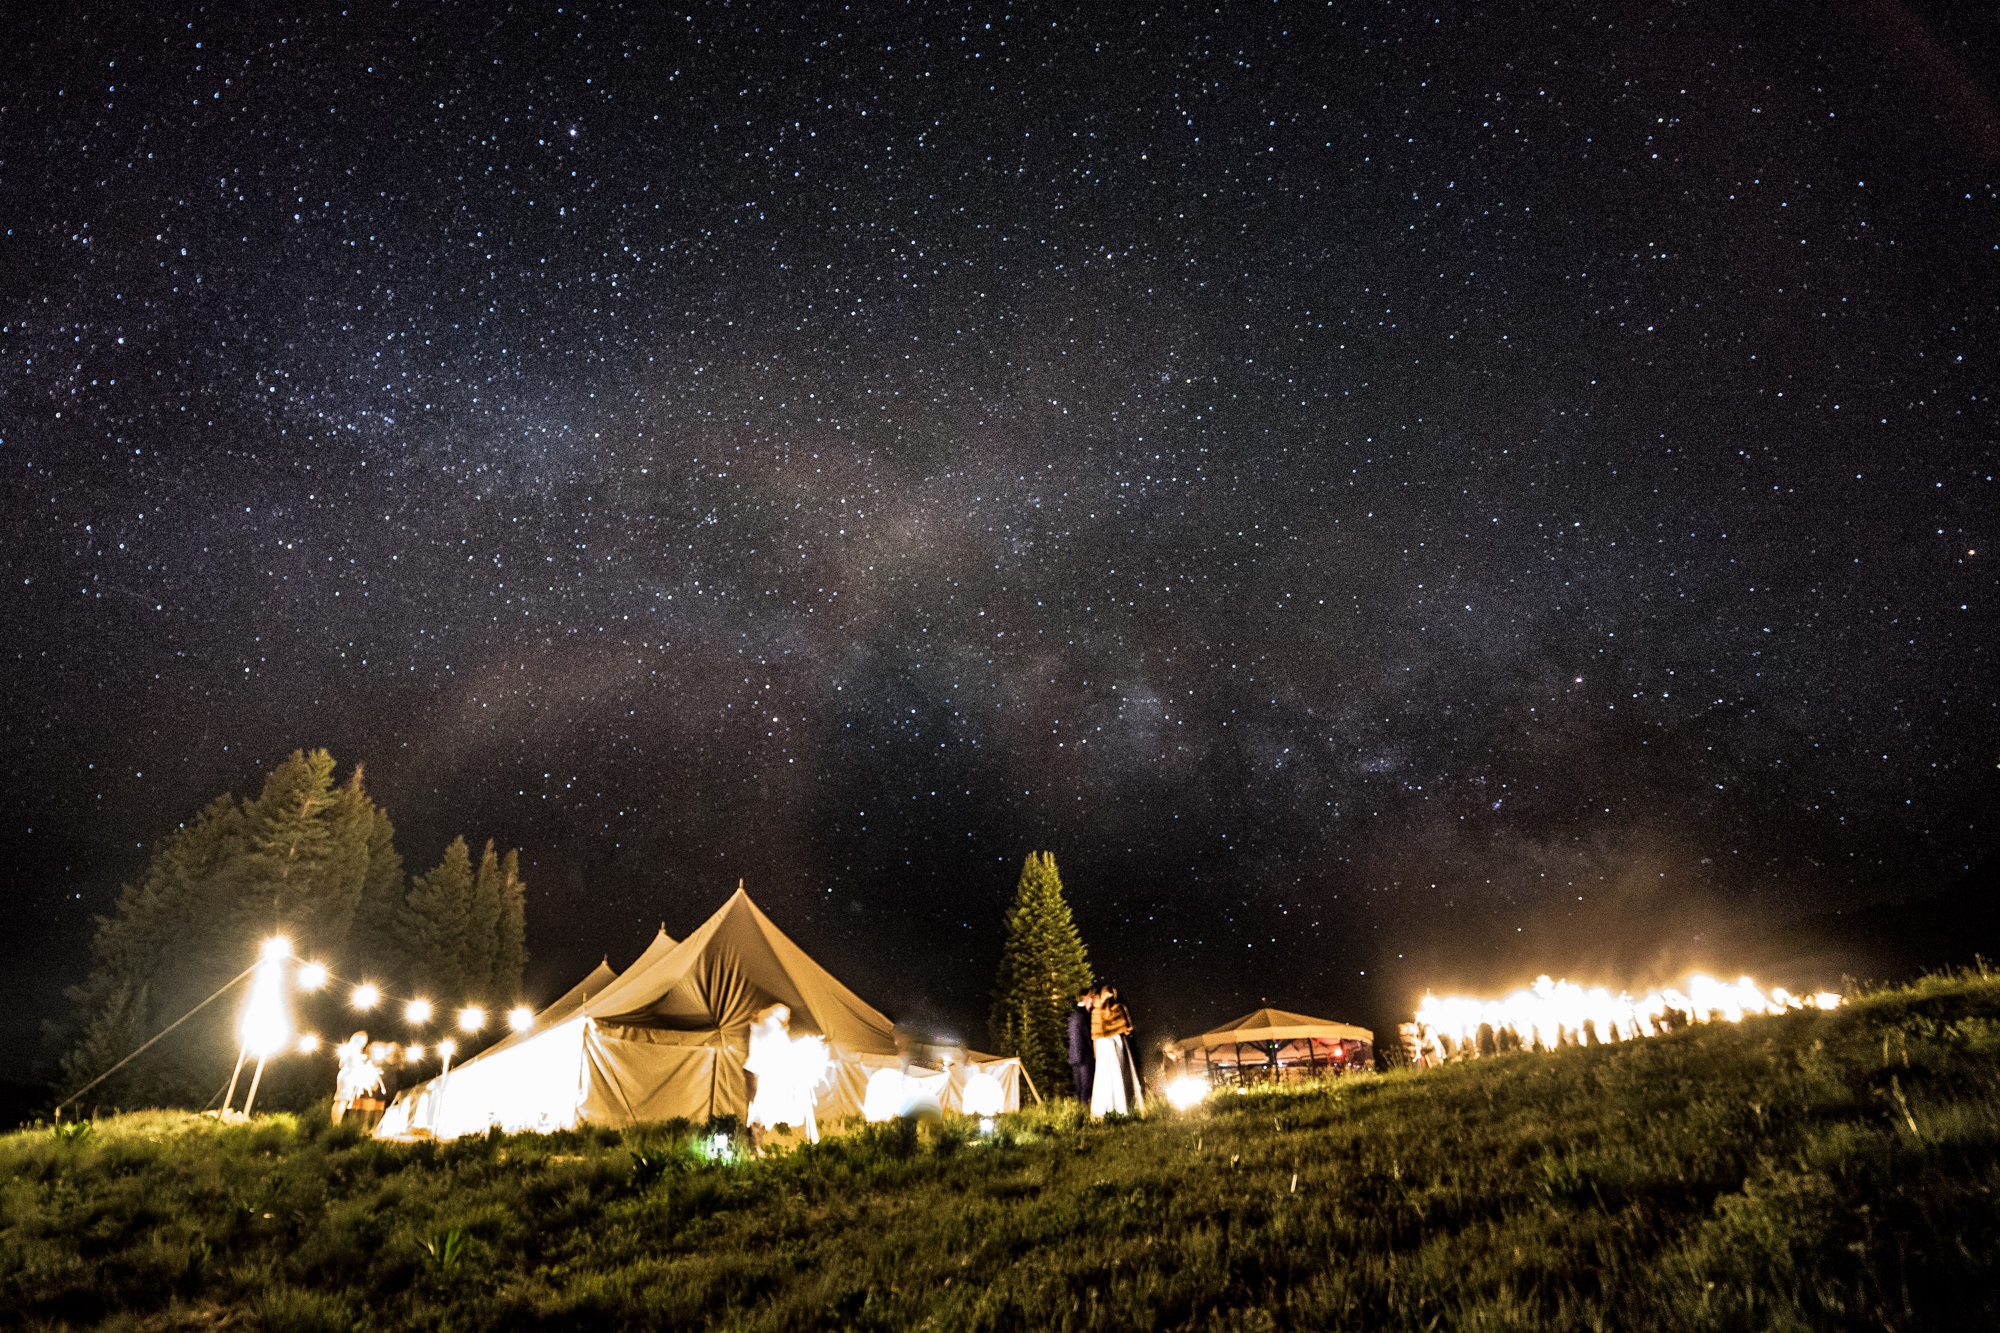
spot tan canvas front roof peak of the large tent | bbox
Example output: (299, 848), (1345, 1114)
(584, 887), (896, 1055)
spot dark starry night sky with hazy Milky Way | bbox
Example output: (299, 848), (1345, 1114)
(0, 0), (2000, 1067)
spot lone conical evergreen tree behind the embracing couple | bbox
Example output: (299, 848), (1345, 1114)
(990, 853), (1092, 1089)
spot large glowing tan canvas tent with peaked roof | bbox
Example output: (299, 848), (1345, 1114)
(376, 887), (1020, 1139)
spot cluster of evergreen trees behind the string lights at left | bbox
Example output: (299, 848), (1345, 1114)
(52, 751), (528, 1107)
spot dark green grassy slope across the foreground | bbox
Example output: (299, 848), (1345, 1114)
(11, 975), (2000, 1331)
